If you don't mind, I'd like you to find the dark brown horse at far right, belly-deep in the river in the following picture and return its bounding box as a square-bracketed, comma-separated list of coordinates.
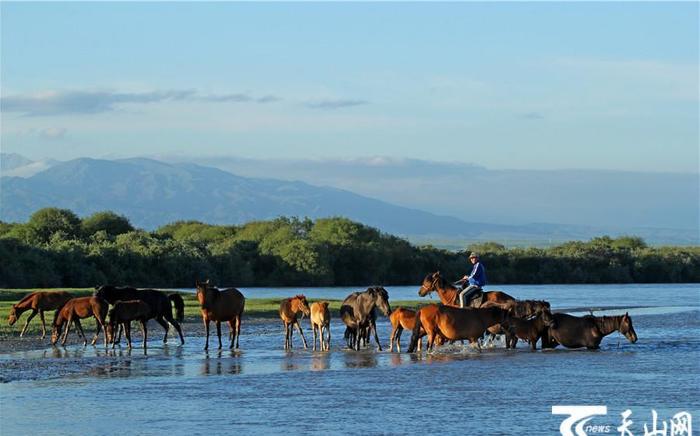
[545, 312, 637, 350]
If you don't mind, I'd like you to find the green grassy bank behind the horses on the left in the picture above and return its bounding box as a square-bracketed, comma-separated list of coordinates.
[0, 288, 428, 336]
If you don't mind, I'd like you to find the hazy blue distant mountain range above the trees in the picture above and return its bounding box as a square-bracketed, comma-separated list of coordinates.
[0, 154, 697, 245]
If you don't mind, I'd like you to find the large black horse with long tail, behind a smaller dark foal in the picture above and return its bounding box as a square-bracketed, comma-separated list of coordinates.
[94, 285, 185, 345]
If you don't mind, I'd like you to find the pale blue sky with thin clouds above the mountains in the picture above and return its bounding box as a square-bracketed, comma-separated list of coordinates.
[0, 2, 700, 173]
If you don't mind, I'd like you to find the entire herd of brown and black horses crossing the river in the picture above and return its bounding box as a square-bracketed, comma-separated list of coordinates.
[8, 272, 637, 352]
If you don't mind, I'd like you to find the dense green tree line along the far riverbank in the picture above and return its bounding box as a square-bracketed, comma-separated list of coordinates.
[0, 208, 700, 288]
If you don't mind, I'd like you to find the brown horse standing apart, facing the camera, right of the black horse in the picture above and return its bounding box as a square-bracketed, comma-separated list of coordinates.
[195, 280, 245, 350]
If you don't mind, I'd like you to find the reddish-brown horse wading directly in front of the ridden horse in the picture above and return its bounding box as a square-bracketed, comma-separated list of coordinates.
[408, 304, 509, 353]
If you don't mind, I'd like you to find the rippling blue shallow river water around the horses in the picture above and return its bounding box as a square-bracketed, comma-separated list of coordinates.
[0, 285, 700, 434]
